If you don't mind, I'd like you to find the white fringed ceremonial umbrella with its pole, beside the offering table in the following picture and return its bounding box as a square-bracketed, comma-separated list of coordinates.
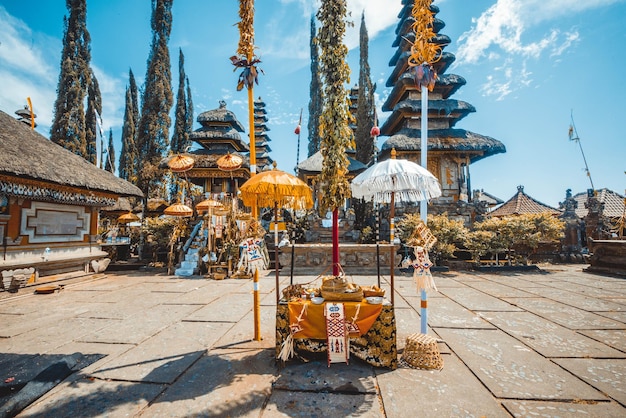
[350, 149, 441, 310]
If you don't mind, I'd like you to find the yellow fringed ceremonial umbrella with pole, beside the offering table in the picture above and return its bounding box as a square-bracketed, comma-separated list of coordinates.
[239, 165, 313, 303]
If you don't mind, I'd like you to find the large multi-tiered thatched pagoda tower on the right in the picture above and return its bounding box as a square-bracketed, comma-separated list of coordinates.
[380, 0, 506, 221]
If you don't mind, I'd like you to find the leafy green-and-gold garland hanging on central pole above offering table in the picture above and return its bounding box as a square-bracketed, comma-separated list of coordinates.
[317, 0, 353, 211]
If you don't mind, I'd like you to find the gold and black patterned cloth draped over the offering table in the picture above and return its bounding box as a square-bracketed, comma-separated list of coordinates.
[276, 300, 398, 370]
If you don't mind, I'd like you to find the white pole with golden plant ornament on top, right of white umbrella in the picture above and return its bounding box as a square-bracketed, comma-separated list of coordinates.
[408, 0, 441, 334]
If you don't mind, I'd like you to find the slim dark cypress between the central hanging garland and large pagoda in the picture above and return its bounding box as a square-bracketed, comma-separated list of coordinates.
[355, 13, 376, 164]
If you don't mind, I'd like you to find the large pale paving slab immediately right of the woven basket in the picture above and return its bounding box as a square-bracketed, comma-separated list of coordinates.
[436, 328, 607, 401]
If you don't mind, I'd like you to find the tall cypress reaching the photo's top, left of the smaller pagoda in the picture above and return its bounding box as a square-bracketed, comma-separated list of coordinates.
[136, 0, 173, 198]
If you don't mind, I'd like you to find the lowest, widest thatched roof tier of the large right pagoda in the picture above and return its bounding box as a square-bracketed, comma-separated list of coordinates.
[381, 128, 506, 162]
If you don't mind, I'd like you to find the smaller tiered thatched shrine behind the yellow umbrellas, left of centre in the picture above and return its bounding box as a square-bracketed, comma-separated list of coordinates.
[186, 101, 250, 194]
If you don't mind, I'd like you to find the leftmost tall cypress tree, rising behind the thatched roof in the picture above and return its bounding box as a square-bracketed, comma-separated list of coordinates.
[50, 0, 91, 158]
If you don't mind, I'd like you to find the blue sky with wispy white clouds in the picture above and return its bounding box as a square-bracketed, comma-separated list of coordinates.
[0, 0, 626, 207]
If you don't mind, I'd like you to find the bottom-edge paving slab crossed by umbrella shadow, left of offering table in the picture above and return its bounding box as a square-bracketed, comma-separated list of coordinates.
[143, 350, 276, 417]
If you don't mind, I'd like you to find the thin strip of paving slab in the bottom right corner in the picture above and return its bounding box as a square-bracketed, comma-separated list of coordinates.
[502, 401, 624, 418]
